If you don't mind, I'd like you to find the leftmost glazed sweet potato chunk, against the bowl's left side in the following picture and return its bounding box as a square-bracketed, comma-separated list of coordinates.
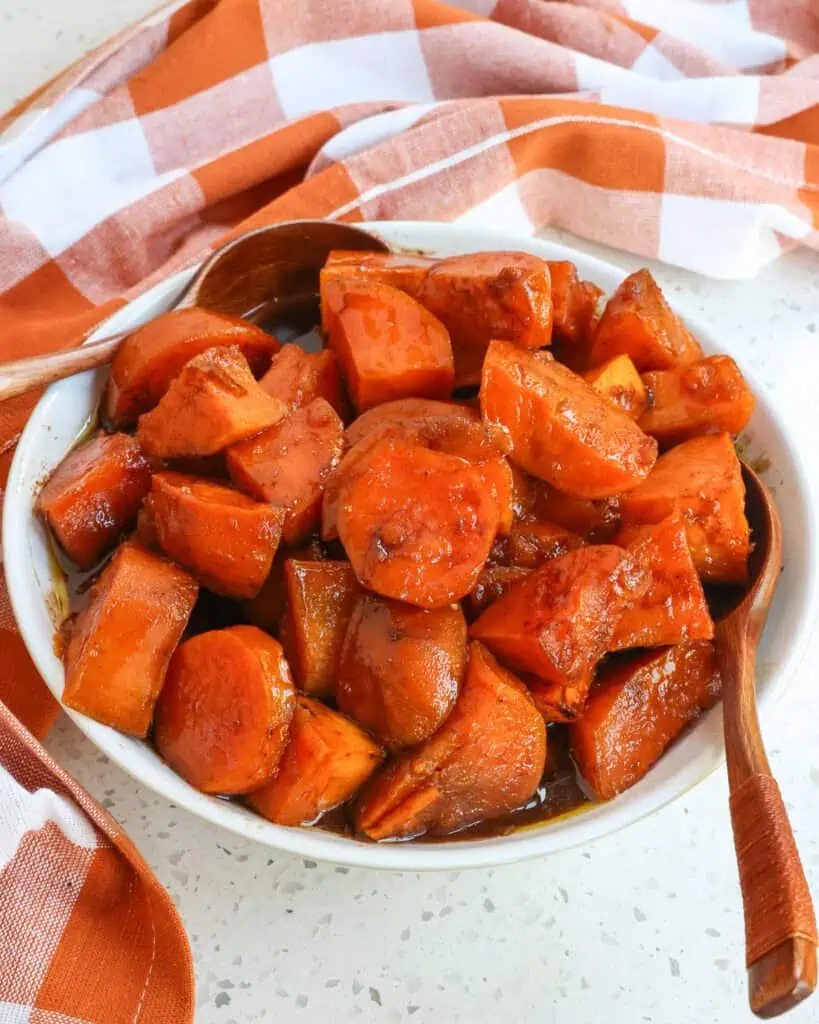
[36, 433, 150, 569]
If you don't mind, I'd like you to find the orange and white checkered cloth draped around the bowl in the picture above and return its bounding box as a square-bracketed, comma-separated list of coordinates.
[0, 0, 819, 1024]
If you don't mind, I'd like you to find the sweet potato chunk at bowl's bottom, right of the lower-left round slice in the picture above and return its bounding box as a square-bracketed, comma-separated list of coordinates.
[247, 693, 384, 825]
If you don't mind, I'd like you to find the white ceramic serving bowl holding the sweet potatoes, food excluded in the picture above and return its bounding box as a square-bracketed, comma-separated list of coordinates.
[3, 222, 819, 870]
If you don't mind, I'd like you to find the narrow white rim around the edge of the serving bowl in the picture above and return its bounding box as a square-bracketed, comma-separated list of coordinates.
[7, 221, 819, 871]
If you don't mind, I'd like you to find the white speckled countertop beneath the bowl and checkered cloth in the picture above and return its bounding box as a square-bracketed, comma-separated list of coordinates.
[0, 0, 819, 1024]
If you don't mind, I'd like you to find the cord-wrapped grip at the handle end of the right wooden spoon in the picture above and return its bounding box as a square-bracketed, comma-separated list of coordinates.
[731, 774, 817, 1017]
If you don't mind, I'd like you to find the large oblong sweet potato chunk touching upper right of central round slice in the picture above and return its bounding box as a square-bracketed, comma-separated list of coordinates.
[480, 341, 657, 498]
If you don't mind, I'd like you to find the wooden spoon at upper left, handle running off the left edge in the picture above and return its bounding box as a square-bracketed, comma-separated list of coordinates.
[0, 220, 387, 401]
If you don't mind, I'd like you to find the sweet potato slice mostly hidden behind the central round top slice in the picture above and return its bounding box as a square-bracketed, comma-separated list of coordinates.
[339, 398, 514, 537]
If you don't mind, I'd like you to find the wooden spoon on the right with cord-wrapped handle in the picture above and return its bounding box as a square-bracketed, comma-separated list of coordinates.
[715, 465, 817, 1018]
